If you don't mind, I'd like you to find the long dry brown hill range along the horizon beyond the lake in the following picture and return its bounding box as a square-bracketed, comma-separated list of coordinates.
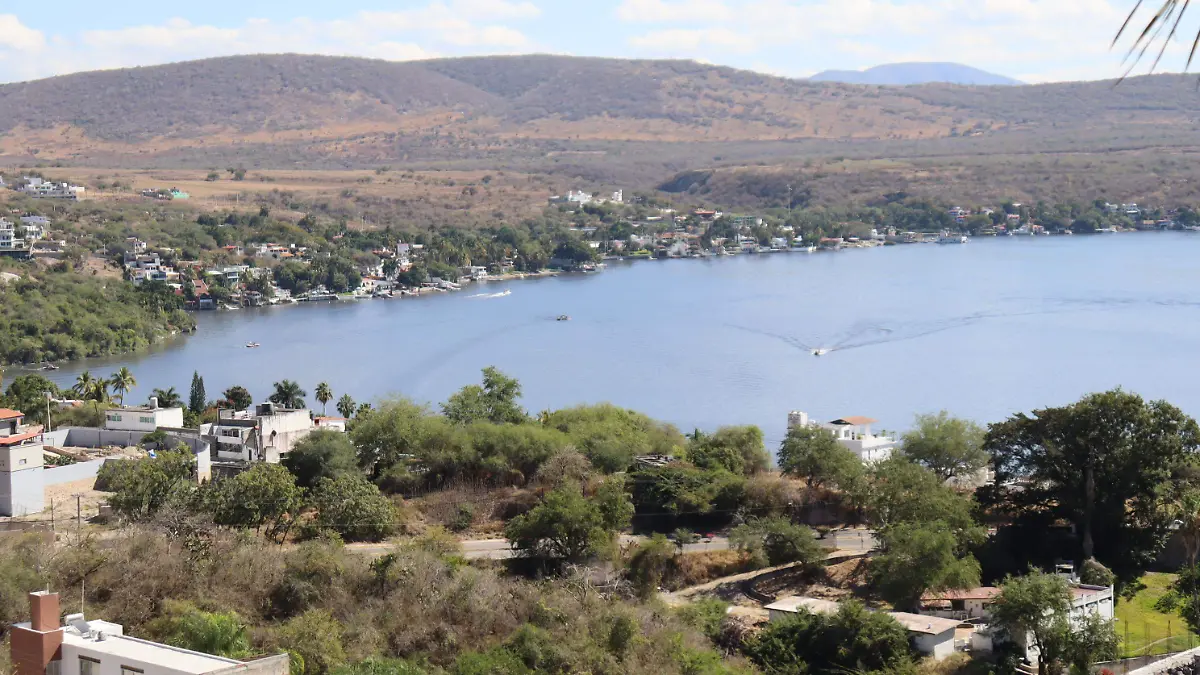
[7, 55, 1200, 198]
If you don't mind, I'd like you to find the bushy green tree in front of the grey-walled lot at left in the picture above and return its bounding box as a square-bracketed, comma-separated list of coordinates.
[96, 450, 196, 520]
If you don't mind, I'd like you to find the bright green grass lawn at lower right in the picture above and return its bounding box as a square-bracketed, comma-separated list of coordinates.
[1115, 573, 1200, 657]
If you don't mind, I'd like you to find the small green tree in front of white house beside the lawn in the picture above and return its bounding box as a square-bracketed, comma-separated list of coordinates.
[991, 571, 1070, 675]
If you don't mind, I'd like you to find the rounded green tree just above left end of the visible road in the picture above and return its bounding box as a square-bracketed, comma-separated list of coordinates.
[312, 473, 396, 542]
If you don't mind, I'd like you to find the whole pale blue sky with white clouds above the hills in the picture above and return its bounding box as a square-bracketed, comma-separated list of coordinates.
[0, 0, 1185, 83]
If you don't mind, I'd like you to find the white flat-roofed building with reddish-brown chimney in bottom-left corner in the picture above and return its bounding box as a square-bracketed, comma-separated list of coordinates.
[8, 591, 290, 675]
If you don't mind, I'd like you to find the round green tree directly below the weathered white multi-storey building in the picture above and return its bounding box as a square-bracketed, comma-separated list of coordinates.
[205, 464, 304, 542]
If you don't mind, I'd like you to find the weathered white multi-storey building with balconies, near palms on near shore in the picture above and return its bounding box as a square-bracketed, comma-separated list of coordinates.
[200, 404, 317, 465]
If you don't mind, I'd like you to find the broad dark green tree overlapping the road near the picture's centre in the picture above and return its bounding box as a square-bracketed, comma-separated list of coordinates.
[504, 485, 631, 562]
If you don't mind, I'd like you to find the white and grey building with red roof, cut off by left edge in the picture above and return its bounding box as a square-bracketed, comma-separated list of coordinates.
[0, 408, 46, 516]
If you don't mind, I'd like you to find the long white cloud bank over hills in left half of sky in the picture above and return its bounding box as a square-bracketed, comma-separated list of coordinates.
[0, 0, 540, 80]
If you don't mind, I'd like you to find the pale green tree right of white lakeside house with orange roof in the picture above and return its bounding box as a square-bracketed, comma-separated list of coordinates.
[902, 411, 989, 480]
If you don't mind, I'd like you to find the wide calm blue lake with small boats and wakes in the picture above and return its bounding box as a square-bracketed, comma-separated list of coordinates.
[30, 233, 1200, 443]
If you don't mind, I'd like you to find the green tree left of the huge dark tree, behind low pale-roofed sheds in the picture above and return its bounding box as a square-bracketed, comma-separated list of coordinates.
[869, 521, 979, 610]
